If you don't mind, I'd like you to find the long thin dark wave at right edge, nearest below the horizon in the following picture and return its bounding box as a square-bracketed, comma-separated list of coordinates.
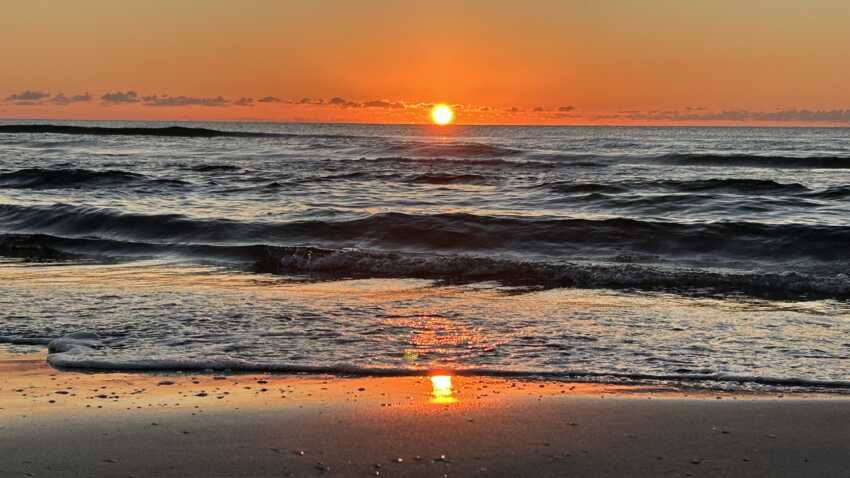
[638, 153, 850, 169]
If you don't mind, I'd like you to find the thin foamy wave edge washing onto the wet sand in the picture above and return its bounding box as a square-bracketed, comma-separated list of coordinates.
[0, 332, 850, 390]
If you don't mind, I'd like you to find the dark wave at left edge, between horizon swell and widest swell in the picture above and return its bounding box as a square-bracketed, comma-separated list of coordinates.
[0, 168, 189, 189]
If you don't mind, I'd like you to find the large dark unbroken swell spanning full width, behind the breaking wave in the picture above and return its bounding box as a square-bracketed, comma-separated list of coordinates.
[0, 204, 850, 262]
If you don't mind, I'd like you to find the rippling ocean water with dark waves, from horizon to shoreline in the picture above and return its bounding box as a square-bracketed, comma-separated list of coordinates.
[0, 121, 850, 391]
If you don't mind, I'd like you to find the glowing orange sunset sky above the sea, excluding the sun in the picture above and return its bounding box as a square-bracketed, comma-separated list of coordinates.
[0, 0, 850, 124]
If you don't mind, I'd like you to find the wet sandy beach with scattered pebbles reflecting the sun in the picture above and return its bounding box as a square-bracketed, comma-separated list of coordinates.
[0, 353, 850, 478]
